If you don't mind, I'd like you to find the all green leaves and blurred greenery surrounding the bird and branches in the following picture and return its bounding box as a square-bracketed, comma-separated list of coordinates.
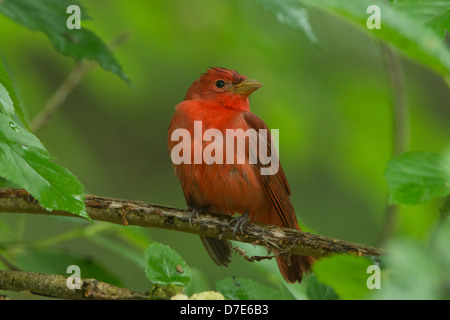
[0, 0, 450, 299]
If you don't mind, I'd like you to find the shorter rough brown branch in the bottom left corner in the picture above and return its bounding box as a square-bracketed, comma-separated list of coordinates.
[0, 270, 149, 300]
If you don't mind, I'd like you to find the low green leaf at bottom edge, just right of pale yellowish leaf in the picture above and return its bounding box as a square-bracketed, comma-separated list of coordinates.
[216, 277, 284, 300]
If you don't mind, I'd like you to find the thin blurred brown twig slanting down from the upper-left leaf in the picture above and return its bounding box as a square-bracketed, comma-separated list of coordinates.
[30, 32, 129, 132]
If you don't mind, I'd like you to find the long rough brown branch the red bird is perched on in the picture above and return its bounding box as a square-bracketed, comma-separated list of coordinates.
[0, 189, 383, 257]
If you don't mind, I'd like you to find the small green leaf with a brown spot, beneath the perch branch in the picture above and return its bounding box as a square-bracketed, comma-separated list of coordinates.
[145, 242, 191, 287]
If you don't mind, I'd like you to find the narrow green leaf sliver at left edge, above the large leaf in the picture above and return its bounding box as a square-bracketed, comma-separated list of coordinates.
[0, 59, 29, 129]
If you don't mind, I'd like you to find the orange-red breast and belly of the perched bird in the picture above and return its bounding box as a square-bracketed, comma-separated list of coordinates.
[169, 100, 264, 214]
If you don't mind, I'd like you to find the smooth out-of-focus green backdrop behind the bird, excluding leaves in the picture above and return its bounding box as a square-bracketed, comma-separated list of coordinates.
[0, 0, 450, 291]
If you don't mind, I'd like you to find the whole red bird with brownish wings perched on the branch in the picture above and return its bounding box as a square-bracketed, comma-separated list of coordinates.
[168, 68, 314, 282]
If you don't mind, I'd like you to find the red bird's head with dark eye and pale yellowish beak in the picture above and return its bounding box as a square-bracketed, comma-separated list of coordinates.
[185, 67, 262, 111]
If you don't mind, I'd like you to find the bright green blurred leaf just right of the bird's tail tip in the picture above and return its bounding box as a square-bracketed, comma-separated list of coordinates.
[313, 254, 373, 300]
